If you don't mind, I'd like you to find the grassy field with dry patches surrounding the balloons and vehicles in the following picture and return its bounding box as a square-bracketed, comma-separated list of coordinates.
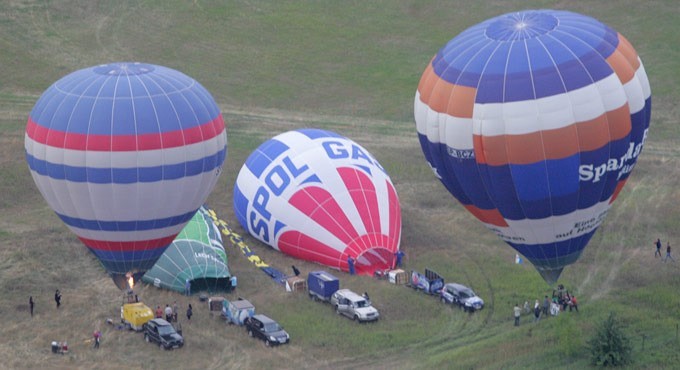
[0, 0, 680, 369]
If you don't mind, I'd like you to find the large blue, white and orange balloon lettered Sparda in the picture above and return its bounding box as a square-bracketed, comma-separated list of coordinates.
[414, 10, 651, 284]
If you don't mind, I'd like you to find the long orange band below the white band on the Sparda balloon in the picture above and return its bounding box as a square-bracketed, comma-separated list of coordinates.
[473, 104, 631, 166]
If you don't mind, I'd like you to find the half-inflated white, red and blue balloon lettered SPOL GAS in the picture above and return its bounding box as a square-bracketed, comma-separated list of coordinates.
[234, 129, 401, 274]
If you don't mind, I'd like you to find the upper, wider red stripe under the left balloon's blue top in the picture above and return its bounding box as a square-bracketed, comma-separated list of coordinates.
[26, 114, 224, 152]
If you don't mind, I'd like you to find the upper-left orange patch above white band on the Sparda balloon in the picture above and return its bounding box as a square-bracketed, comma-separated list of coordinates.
[418, 63, 477, 118]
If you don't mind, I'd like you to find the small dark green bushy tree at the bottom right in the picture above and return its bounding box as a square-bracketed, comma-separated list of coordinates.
[588, 312, 633, 366]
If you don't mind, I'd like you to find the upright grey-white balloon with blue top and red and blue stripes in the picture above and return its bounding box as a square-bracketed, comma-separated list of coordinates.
[25, 62, 227, 289]
